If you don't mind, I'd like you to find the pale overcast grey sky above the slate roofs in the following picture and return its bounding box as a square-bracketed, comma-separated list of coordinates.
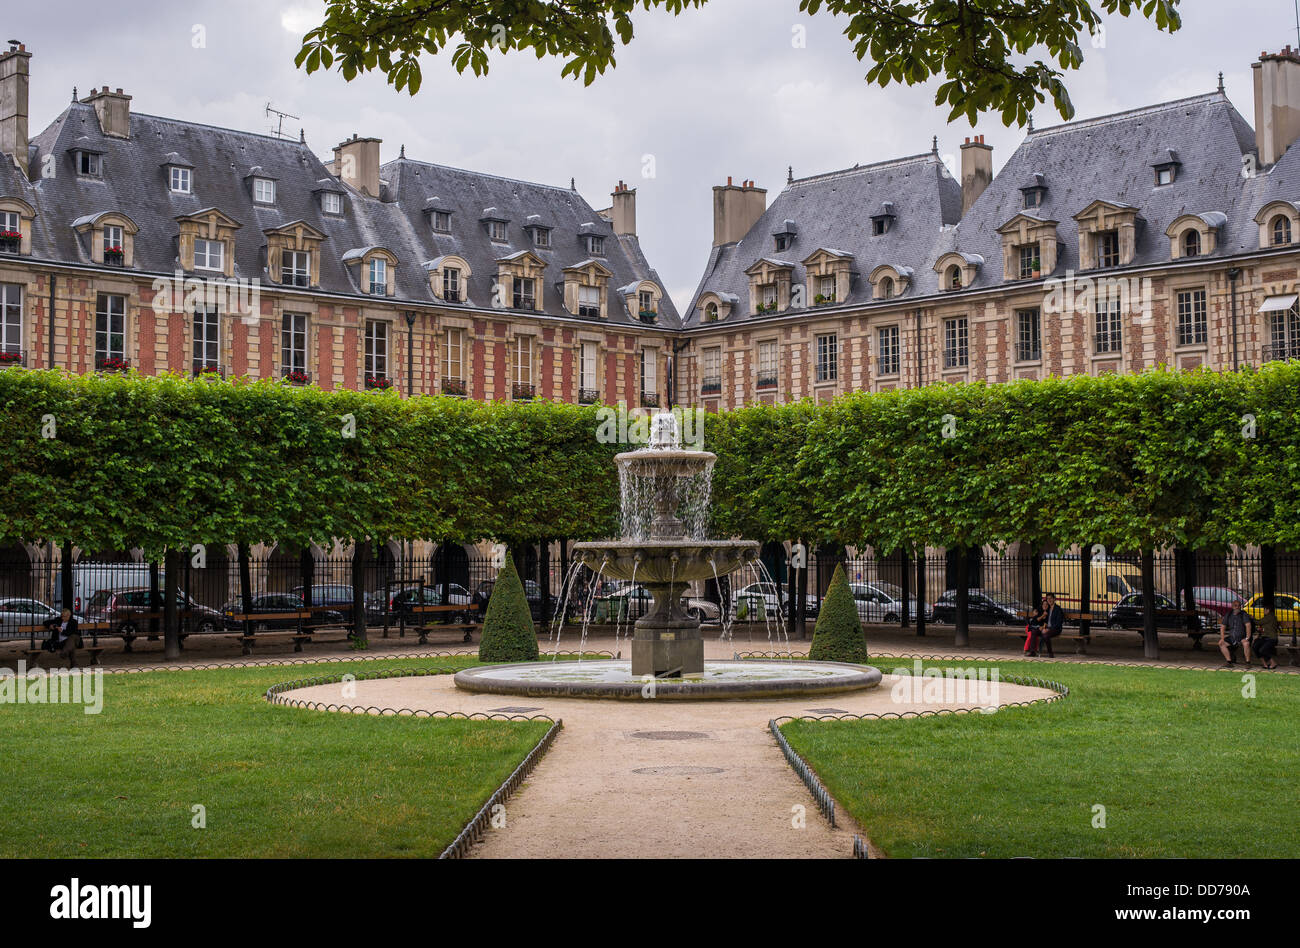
[10, 0, 1300, 308]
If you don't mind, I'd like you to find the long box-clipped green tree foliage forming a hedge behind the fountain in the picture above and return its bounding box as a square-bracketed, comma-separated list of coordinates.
[0, 363, 1300, 553]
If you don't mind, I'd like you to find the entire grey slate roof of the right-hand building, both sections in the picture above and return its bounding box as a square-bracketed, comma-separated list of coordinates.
[686, 91, 1300, 326]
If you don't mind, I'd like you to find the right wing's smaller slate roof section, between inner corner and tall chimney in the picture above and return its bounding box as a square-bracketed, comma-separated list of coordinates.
[684, 152, 962, 326]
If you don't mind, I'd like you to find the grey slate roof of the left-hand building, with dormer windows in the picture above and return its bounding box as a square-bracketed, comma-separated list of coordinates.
[10, 101, 679, 329]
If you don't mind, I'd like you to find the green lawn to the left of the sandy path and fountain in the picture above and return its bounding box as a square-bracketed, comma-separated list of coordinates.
[0, 658, 549, 858]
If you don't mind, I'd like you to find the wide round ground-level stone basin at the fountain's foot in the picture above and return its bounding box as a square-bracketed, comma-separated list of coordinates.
[455, 659, 880, 701]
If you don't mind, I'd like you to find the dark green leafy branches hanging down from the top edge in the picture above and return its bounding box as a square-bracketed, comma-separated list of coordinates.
[294, 0, 1182, 125]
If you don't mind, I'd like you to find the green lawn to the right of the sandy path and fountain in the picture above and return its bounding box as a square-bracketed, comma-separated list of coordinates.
[783, 659, 1300, 858]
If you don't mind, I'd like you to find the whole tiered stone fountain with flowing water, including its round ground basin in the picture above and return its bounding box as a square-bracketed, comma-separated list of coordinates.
[455, 412, 880, 698]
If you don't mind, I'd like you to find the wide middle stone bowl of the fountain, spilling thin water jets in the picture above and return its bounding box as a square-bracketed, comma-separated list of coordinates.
[573, 540, 759, 583]
